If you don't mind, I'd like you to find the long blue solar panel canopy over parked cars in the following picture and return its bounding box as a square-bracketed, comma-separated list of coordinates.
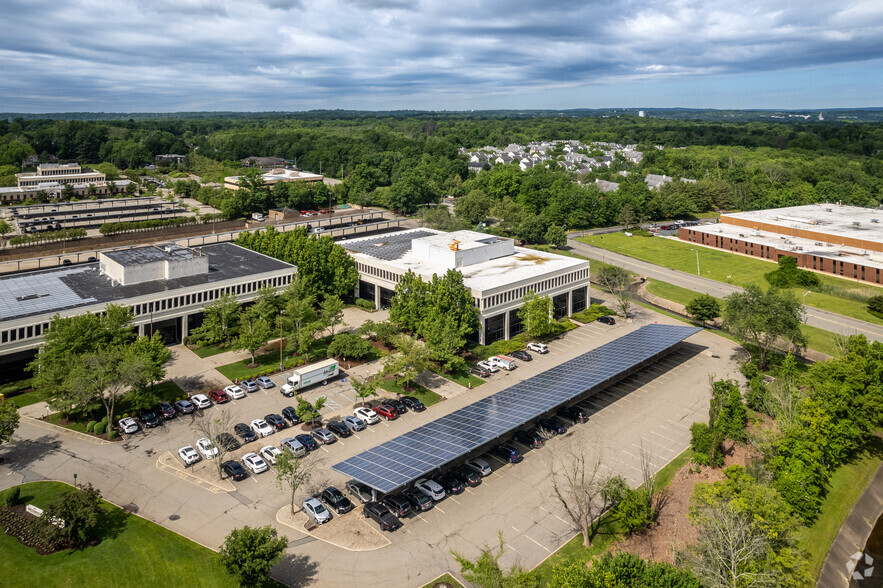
[331, 324, 701, 492]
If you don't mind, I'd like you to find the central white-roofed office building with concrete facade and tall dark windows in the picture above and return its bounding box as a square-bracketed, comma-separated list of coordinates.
[340, 229, 589, 345]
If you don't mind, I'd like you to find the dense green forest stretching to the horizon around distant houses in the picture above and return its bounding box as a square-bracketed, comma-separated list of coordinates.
[0, 112, 883, 234]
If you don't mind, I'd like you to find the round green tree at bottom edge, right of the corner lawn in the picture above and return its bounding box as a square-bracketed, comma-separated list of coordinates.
[220, 525, 288, 586]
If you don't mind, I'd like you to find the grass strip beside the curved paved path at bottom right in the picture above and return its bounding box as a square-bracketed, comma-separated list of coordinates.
[798, 437, 883, 584]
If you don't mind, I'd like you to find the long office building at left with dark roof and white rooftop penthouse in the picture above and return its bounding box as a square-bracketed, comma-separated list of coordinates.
[0, 243, 296, 382]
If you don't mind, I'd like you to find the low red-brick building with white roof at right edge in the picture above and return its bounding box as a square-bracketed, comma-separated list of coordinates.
[679, 204, 883, 284]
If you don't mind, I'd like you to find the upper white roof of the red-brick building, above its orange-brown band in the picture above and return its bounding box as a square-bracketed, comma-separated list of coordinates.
[721, 204, 883, 243]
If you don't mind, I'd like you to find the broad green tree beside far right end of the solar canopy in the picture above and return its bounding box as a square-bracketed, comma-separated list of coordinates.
[724, 284, 806, 370]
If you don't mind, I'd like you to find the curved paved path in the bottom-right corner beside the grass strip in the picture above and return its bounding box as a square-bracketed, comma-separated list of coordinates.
[816, 465, 883, 588]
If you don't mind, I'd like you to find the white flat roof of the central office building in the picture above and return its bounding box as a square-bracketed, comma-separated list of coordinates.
[339, 229, 589, 291]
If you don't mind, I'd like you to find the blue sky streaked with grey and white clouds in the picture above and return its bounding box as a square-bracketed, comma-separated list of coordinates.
[0, 0, 883, 112]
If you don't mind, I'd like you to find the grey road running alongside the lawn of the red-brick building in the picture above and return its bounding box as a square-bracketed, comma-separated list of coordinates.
[567, 238, 883, 341]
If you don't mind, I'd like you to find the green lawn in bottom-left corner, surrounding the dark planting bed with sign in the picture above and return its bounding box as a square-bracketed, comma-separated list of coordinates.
[0, 482, 238, 588]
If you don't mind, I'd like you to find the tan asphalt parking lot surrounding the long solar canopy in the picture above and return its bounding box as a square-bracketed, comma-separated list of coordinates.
[0, 310, 740, 586]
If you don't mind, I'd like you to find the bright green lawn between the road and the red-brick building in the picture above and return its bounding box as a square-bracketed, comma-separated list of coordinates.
[579, 233, 883, 324]
